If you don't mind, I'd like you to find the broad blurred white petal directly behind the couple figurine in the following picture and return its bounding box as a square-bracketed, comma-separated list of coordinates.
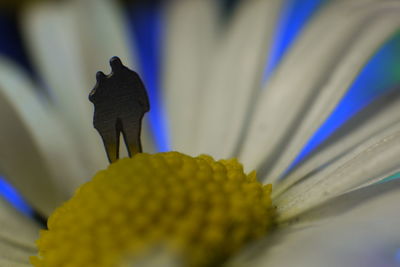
[22, 0, 153, 161]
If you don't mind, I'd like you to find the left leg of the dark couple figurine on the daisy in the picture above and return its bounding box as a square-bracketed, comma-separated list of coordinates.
[95, 123, 119, 163]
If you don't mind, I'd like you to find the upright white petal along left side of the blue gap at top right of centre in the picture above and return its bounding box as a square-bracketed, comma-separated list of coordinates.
[196, 0, 281, 158]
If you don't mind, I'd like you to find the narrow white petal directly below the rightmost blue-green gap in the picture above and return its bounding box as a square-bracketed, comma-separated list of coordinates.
[272, 91, 400, 197]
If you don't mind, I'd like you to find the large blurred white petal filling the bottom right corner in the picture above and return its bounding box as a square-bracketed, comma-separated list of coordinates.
[230, 181, 400, 267]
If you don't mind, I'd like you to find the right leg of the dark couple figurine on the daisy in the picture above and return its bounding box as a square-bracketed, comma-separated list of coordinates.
[122, 118, 142, 157]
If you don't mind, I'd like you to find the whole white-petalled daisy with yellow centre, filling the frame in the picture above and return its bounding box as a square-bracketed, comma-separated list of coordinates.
[0, 0, 400, 266]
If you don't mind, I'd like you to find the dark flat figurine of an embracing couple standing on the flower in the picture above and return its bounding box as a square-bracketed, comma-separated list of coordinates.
[89, 57, 150, 163]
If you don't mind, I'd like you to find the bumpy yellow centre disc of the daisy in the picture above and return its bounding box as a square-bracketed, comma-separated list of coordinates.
[31, 152, 274, 267]
